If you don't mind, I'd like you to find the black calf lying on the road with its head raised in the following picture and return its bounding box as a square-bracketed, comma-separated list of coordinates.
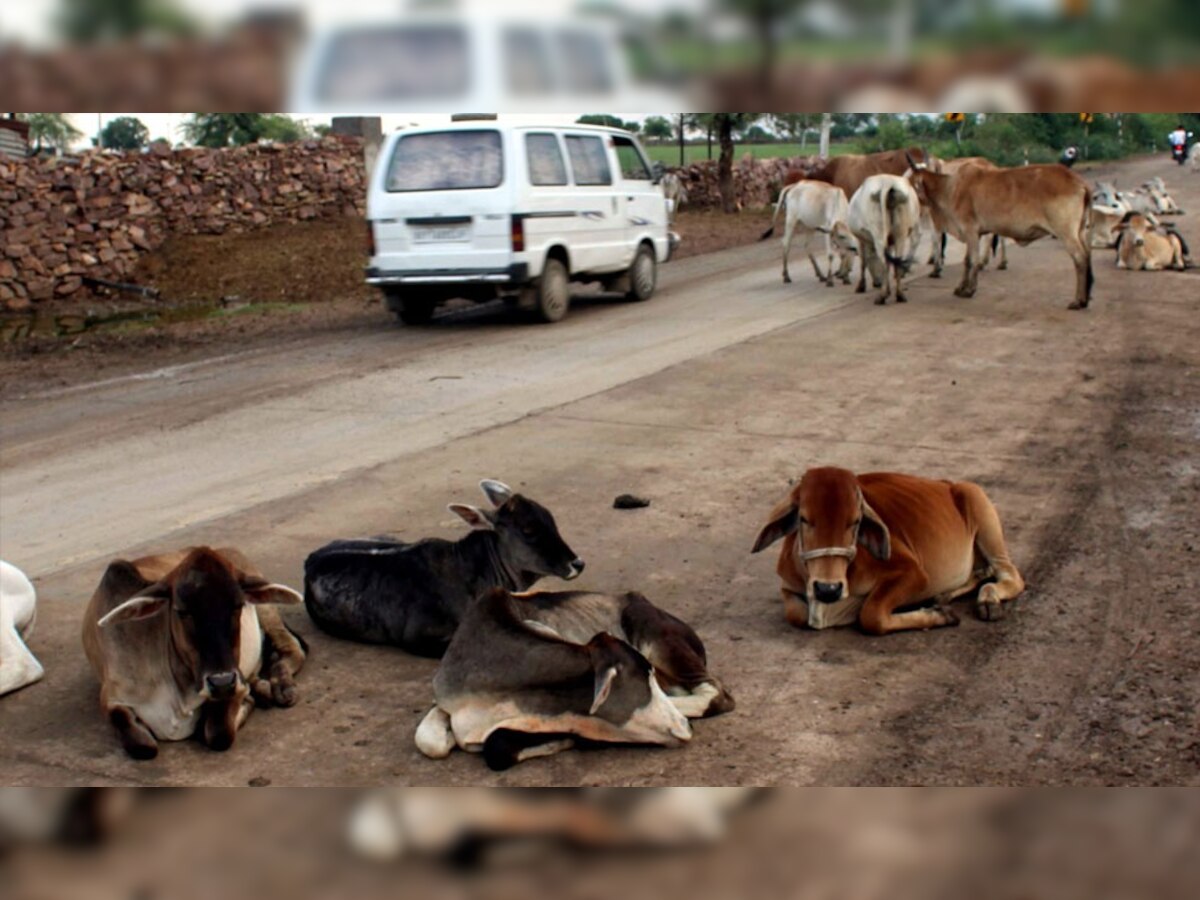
[304, 479, 583, 656]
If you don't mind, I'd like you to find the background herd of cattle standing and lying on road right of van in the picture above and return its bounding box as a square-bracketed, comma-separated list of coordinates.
[748, 148, 1190, 310]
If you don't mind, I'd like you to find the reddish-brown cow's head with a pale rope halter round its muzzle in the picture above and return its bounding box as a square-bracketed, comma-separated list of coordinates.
[751, 468, 892, 604]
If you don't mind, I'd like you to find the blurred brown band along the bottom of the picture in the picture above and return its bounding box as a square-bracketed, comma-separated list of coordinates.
[0, 787, 1200, 900]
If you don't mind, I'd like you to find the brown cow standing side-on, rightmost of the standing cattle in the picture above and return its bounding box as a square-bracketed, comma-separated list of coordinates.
[910, 160, 1093, 310]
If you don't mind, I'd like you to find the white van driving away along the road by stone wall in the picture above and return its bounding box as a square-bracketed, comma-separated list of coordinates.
[367, 118, 678, 324]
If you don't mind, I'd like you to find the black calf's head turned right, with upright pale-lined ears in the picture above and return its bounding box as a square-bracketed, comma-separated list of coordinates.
[450, 480, 584, 581]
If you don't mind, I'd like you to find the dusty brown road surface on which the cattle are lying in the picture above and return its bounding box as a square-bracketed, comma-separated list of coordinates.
[0, 160, 1200, 785]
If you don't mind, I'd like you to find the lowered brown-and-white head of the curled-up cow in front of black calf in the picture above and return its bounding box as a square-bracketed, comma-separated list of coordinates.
[587, 632, 691, 746]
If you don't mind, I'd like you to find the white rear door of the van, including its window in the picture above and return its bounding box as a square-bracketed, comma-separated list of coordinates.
[371, 128, 511, 274]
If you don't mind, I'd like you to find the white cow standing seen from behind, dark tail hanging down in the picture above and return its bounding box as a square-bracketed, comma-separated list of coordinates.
[848, 175, 921, 305]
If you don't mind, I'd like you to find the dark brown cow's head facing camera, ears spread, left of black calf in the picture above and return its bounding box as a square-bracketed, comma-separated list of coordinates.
[98, 547, 302, 701]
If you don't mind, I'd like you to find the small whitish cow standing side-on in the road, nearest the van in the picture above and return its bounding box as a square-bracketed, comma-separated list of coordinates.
[758, 181, 858, 287]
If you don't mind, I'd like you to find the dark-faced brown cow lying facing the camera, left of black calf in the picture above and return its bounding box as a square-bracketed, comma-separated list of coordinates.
[83, 547, 306, 760]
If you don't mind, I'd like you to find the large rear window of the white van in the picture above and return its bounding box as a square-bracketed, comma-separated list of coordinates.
[386, 130, 504, 192]
